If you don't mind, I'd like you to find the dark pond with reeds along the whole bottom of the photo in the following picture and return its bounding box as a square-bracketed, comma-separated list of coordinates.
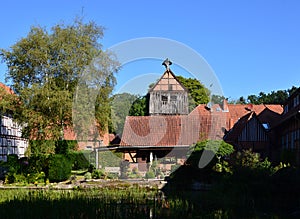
[0, 186, 299, 219]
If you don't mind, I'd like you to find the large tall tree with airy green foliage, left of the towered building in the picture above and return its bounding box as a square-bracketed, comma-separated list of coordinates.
[0, 19, 118, 139]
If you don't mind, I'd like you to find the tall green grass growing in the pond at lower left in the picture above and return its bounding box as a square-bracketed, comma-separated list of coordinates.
[0, 187, 202, 219]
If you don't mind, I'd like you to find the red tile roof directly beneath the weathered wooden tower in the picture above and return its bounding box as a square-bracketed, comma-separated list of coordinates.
[121, 115, 199, 147]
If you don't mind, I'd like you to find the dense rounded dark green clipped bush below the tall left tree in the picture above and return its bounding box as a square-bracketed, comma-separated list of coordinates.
[48, 154, 72, 182]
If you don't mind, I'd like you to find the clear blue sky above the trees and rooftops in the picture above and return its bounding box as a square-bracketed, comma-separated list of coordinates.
[0, 0, 300, 99]
